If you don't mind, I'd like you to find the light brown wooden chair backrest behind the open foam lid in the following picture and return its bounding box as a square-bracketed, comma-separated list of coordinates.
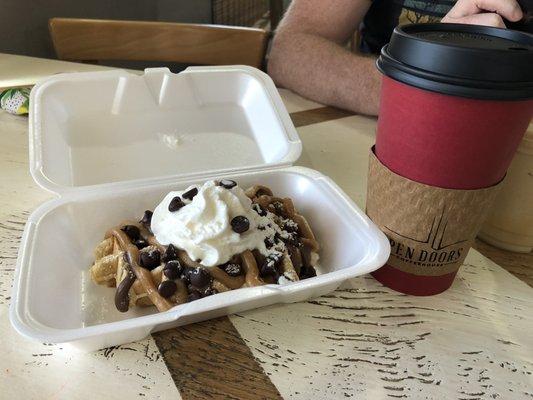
[49, 18, 268, 68]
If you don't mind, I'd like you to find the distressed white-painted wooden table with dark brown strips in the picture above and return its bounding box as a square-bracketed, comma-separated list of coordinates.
[0, 55, 533, 400]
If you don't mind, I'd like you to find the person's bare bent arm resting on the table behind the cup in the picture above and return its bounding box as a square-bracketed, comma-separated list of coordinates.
[268, 0, 381, 115]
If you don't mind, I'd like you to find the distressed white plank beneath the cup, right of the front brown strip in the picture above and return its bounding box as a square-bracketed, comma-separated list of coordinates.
[231, 250, 533, 400]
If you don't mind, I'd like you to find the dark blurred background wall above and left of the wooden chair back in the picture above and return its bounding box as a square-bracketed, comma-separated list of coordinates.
[0, 0, 289, 58]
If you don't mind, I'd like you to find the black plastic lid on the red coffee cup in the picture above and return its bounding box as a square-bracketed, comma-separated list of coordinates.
[377, 24, 533, 100]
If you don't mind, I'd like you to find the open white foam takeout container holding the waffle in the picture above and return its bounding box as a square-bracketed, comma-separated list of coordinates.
[10, 66, 389, 351]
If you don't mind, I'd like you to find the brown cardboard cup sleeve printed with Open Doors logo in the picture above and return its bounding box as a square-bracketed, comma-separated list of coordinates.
[366, 149, 501, 276]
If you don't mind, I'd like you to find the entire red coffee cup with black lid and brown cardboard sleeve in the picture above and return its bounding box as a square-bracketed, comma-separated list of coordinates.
[367, 24, 533, 295]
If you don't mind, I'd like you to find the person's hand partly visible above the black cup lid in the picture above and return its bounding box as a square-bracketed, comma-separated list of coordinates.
[441, 0, 523, 28]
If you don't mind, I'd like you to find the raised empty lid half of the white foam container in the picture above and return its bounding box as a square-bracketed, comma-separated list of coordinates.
[29, 66, 302, 194]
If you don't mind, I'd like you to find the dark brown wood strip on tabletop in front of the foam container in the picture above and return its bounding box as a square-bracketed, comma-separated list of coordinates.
[153, 317, 282, 400]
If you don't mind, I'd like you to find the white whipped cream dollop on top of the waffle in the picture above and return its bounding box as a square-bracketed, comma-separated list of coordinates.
[151, 181, 283, 267]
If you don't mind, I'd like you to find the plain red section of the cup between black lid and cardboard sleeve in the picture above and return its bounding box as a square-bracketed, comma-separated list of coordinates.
[376, 78, 533, 189]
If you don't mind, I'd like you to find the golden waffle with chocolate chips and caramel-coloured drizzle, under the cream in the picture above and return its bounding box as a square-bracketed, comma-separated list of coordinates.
[90, 185, 319, 312]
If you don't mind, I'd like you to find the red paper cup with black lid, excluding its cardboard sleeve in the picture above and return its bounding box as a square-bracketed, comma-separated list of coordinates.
[373, 24, 533, 295]
